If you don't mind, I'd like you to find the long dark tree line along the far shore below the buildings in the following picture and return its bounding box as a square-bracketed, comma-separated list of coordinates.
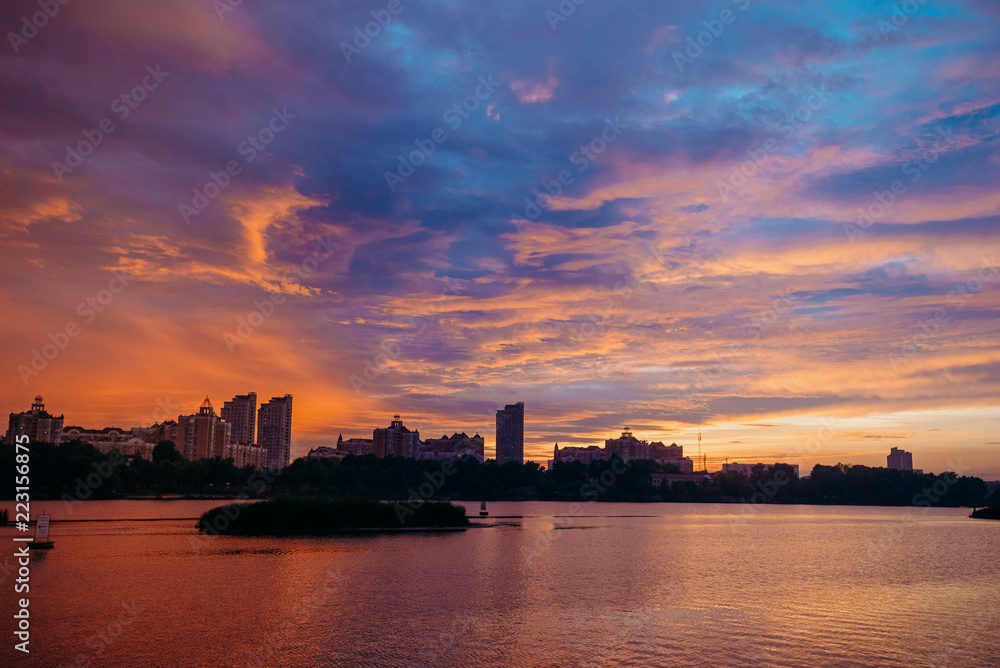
[0, 441, 1000, 507]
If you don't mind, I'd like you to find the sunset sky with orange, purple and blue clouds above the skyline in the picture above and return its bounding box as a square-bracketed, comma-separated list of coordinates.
[0, 0, 1000, 480]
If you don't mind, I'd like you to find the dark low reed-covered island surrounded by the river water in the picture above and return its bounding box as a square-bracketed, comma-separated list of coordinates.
[198, 497, 470, 536]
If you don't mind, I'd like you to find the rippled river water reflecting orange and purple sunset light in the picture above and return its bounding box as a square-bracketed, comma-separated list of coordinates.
[0, 501, 1000, 668]
